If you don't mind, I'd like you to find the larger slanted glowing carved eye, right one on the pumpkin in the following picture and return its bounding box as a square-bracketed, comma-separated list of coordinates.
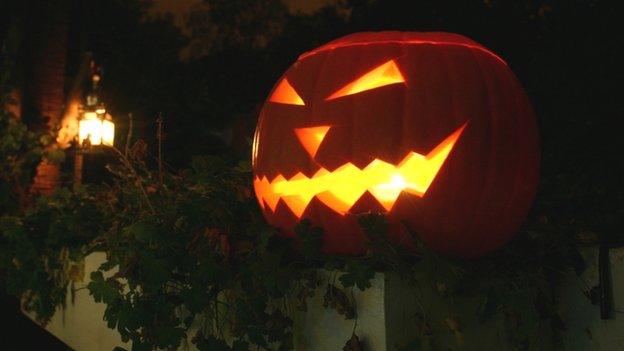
[326, 60, 405, 100]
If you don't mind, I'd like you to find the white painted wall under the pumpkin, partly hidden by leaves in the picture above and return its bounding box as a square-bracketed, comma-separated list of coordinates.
[24, 249, 624, 351]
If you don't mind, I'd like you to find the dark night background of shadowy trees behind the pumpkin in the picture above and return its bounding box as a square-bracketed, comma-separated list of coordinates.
[0, 0, 624, 350]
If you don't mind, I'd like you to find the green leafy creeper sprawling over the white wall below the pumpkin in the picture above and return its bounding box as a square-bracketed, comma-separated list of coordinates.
[0, 135, 582, 350]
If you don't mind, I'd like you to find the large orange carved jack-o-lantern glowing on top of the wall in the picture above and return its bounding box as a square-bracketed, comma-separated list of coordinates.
[253, 32, 539, 257]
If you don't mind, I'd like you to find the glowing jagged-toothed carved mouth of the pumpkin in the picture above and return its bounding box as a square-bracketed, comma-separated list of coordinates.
[254, 123, 466, 218]
